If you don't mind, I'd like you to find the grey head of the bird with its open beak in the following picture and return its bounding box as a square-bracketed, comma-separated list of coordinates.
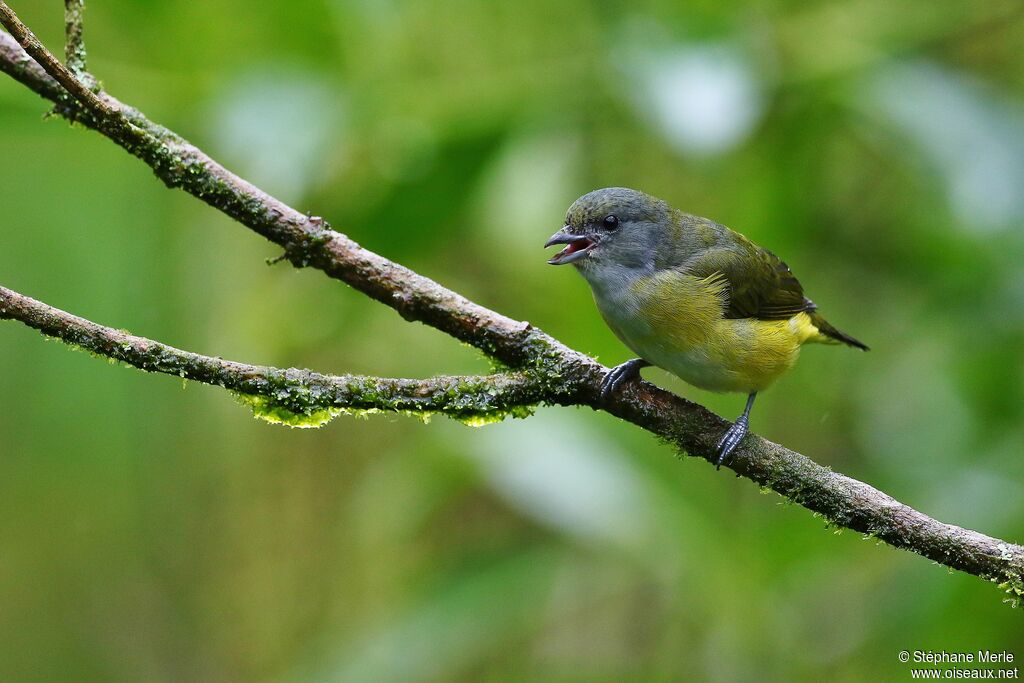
[544, 187, 671, 275]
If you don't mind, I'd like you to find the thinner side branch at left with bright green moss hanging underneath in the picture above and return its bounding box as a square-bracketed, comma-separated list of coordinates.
[0, 287, 555, 427]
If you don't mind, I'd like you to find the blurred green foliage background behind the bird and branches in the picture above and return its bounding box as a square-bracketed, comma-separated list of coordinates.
[0, 0, 1024, 682]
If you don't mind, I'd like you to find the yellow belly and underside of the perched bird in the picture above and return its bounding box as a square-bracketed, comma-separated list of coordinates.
[598, 272, 819, 393]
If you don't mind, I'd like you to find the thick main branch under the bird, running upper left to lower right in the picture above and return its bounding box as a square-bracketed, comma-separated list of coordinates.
[0, 2, 1024, 601]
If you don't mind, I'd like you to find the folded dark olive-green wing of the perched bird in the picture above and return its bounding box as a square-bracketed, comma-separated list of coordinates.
[684, 242, 814, 321]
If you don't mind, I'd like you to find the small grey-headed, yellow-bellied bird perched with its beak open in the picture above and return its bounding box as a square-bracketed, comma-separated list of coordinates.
[544, 187, 867, 467]
